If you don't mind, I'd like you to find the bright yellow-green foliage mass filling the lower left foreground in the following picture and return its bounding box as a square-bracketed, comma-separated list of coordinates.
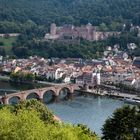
[0, 100, 98, 140]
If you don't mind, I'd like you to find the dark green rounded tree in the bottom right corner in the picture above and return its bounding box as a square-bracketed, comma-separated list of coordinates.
[102, 106, 140, 140]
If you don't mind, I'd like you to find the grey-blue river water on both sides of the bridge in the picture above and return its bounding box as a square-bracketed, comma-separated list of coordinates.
[0, 82, 129, 135]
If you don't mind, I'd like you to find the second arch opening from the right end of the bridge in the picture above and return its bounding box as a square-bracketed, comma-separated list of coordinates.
[43, 89, 56, 104]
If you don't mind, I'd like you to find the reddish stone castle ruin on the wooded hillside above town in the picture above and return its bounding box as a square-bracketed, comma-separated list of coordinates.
[44, 23, 120, 41]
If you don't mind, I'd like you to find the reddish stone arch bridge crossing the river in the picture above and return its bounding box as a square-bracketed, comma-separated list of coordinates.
[0, 84, 79, 104]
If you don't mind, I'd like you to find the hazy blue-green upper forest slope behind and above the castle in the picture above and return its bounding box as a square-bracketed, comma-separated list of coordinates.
[0, 0, 140, 31]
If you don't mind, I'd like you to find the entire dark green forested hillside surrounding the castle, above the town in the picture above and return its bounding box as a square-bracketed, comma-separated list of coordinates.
[0, 0, 140, 58]
